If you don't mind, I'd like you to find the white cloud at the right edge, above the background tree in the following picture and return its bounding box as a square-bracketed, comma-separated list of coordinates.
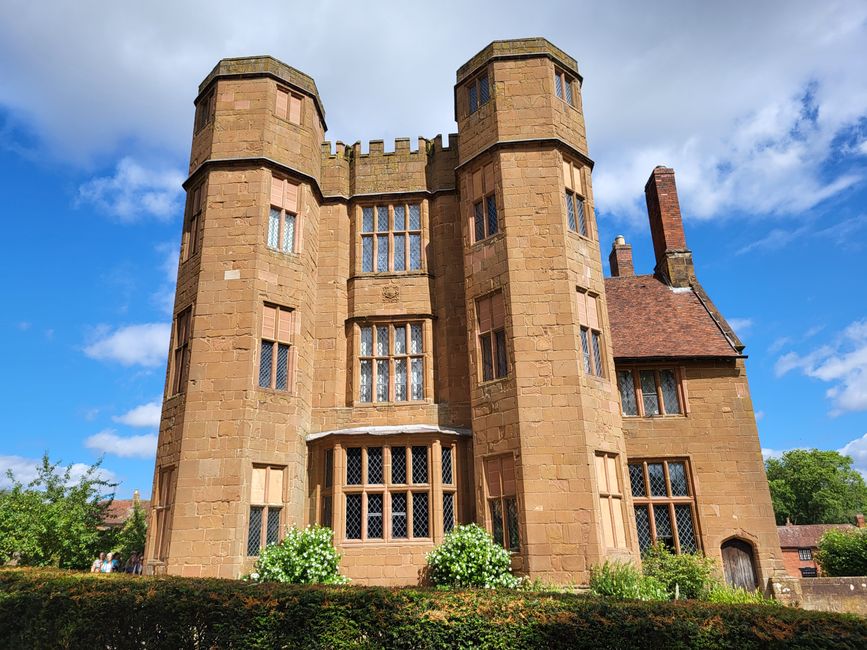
[774, 320, 867, 415]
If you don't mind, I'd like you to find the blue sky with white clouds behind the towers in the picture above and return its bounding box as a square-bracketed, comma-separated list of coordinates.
[0, 0, 867, 497]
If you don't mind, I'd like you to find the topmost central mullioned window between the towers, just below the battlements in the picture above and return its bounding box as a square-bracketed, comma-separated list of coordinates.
[359, 203, 424, 273]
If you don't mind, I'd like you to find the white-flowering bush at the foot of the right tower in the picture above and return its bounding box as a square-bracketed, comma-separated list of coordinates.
[427, 524, 520, 589]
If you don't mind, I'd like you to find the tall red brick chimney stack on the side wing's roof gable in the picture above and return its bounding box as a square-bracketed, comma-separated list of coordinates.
[644, 166, 695, 287]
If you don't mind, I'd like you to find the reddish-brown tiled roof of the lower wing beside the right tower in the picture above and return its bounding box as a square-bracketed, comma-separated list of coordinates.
[605, 275, 740, 359]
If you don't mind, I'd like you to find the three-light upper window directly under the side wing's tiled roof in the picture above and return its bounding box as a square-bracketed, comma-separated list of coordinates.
[617, 367, 686, 417]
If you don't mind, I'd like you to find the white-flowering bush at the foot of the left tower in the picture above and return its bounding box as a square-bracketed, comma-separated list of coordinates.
[250, 526, 349, 585]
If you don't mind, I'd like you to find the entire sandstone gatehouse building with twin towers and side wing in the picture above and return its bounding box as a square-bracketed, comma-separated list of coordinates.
[147, 39, 782, 584]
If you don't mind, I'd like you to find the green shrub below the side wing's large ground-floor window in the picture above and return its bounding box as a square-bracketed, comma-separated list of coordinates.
[641, 544, 719, 599]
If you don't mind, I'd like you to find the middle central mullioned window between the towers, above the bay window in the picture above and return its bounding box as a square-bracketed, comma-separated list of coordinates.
[358, 321, 426, 402]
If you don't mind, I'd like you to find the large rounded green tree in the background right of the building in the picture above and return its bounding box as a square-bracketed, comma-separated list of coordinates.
[765, 449, 867, 525]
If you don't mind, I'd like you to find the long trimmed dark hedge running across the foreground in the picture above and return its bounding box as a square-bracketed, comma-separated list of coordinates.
[0, 569, 867, 650]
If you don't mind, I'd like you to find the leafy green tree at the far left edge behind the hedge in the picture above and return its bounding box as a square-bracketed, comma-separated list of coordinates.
[0, 454, 116, 569]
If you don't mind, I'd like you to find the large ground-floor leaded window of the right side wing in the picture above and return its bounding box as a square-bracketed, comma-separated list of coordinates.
[629, 459, 700, 553]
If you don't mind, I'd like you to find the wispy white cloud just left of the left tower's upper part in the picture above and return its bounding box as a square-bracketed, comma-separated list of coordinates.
[78, 157, 184, 223]
